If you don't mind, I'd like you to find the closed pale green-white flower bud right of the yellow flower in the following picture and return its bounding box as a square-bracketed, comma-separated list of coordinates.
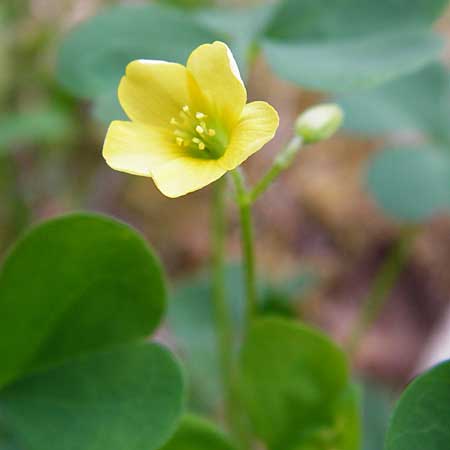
[295, 103, 344, 144]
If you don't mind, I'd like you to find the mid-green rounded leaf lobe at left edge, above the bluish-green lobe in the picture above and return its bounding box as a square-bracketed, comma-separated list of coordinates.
[0, 214, 166, 385]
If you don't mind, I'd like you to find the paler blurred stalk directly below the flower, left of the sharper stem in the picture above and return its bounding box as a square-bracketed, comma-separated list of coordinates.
[212, 177, 233, 423]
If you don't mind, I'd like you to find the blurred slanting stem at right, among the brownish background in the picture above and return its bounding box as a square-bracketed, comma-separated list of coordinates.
[346, 227, 418, 356]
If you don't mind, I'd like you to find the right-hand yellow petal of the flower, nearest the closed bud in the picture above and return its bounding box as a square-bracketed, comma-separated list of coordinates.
[218, 102, 279, 170]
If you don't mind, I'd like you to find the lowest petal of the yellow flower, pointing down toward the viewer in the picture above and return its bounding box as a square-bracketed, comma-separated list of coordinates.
[153, 156, 226, 198]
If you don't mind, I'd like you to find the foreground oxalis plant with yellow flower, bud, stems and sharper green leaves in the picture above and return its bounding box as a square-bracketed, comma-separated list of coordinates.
[0, 37, 450, 450]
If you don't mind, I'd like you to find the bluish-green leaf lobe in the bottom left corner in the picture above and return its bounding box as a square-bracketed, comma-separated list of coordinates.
[0, 343, 183, 450]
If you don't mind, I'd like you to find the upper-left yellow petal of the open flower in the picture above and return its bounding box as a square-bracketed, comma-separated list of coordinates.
[119, 59, 190, 127]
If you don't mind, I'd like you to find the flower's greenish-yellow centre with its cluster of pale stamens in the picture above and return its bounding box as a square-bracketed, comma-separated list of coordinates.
[170, 105, 228, 159]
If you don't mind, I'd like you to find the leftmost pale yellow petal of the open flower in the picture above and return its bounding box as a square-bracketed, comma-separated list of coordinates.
[103, 121, 182, 177]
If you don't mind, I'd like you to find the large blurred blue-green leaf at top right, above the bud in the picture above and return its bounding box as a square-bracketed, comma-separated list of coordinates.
[263, 0, 448, 92]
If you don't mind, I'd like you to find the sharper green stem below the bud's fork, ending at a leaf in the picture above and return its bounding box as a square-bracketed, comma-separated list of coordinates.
[231, 169, 257, 330]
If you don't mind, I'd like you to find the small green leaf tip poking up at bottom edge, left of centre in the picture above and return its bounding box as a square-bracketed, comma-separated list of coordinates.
[160, 416, 234, 450]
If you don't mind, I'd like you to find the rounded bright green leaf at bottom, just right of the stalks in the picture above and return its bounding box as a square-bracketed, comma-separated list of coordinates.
[239, 318, 360, 450]
